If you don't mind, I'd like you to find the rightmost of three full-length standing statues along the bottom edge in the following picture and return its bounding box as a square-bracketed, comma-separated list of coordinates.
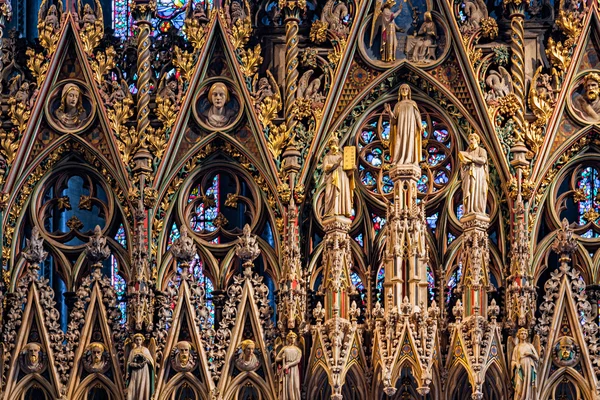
[510, 328, 539, 400]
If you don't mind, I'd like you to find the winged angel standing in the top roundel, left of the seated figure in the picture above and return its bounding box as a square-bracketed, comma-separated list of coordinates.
[369, 0, 402, 62]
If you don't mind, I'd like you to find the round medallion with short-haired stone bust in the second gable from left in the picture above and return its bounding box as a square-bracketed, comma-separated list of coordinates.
[193, 78, 243, 131]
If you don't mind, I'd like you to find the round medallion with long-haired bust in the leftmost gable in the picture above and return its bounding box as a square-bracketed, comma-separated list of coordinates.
[45, 79, 96, 133]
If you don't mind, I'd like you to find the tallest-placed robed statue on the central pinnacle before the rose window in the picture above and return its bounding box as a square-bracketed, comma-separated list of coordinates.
[385, 83, 423, 166]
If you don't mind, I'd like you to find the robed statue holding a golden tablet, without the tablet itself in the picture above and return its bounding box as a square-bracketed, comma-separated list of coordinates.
[323, 138, 354, 217]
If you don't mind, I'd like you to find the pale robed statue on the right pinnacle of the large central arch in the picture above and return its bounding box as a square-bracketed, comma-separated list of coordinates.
[458, 133, 488, 214]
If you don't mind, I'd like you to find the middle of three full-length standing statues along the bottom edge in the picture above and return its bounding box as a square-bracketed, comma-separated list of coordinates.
[275, 331, 302, 400]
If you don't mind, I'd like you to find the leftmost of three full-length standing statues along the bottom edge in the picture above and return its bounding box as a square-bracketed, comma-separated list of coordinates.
[126, 333, 154, 400]
